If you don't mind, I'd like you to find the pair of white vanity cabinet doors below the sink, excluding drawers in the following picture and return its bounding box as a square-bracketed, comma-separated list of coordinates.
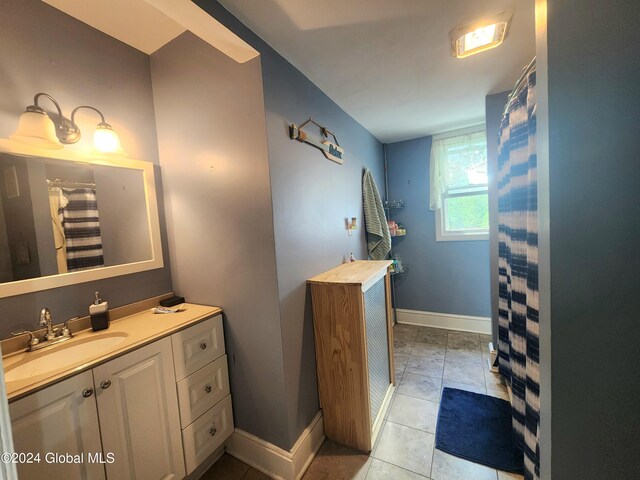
[9, 338, 185, 480]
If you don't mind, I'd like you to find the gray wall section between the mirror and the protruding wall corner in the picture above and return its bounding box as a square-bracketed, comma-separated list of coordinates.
[151, 32, 288, 445]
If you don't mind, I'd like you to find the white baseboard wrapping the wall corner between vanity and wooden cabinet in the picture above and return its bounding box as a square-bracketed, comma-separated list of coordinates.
[227, 411, 325, 480]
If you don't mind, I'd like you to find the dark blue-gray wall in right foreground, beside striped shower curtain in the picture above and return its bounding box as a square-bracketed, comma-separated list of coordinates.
[538, 0, 640, 480]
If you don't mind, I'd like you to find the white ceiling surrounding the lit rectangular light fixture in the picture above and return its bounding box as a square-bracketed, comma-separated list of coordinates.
[219, 0, 535, 142]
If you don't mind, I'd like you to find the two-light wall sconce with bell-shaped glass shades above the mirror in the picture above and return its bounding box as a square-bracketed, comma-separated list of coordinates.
[9, 92, 127, 156]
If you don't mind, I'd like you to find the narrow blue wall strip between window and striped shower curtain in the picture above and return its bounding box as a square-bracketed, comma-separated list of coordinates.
[485, 92, 509, 348]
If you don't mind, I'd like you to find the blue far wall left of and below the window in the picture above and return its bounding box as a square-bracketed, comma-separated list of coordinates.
[387, 137, 491, 317]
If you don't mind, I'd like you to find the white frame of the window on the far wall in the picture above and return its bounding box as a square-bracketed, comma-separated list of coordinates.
[432, 124, 489, 242]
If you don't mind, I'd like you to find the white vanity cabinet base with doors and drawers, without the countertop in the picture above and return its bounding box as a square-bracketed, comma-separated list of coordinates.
[9, 315, 233, 480]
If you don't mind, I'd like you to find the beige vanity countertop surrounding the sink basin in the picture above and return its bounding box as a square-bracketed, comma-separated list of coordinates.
[2, 303, 222, 401]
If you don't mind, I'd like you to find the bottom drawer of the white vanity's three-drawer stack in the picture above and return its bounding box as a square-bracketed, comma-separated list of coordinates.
[182, 395, 233, 475]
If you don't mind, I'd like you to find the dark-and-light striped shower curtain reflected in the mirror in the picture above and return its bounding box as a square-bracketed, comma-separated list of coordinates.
[62, 188, 104, 272]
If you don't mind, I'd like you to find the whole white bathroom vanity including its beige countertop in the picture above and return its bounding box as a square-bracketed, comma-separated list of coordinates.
[3, 304, 233, 480]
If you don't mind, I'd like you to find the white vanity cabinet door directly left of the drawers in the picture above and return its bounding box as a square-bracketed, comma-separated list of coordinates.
[93, 338, 185, 480]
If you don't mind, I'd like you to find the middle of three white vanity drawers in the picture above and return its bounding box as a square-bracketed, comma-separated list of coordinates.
[178, 355, 229, 428]
